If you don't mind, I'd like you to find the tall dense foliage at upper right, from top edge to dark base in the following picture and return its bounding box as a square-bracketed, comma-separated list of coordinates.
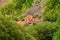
[43, 0, 60, 22]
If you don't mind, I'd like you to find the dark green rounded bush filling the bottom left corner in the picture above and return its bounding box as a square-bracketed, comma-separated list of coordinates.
[0, 17, 25, 40]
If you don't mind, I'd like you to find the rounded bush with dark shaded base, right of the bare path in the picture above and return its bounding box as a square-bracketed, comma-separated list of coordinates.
[43, 10, 57, 22]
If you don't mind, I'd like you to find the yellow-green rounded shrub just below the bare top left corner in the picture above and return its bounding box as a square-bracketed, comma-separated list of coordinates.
[0, 4, 15, 15]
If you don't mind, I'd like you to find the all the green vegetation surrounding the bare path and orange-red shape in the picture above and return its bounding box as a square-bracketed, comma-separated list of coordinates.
[0, 0, 60, 40]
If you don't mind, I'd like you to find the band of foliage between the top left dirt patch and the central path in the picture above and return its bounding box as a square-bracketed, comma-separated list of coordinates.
[0, 0, 33, 15]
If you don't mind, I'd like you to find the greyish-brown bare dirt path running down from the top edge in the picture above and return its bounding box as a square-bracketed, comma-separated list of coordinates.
[25, 0, 45, 15]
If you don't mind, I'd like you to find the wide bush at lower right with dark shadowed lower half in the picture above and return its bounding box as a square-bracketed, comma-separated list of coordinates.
[25, 22, 59, 40]
